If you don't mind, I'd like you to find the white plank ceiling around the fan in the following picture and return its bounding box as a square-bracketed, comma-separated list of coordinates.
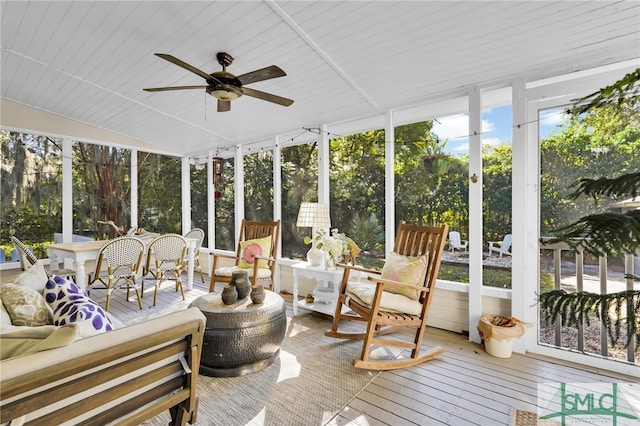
[0, 0, 640, 156]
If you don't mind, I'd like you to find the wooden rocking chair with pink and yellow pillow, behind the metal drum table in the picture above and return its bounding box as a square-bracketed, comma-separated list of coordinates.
[209, 219, 280, 292]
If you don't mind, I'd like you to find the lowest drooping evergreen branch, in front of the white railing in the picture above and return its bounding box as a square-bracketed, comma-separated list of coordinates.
[540, 290, 640, 350]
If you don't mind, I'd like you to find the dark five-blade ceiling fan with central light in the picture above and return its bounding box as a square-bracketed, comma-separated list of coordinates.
[142, 52, 293, 112]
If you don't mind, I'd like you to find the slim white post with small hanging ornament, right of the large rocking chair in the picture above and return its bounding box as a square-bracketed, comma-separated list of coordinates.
[469, 88, 483, 343]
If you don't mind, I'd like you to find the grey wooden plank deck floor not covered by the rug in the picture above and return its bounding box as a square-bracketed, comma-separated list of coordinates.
[77, 278, 638, 426]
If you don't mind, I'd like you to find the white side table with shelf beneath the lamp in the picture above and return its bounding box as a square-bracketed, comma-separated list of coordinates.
[291, 262, 344, 316]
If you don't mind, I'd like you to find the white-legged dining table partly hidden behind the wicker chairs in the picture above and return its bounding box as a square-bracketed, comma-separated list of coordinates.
[47, 238, 198, 290]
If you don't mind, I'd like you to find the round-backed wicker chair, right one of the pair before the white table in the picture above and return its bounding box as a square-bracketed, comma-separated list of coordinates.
[142, 234, 187, 306]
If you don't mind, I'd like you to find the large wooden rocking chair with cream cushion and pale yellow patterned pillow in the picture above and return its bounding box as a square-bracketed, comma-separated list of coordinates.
[325, 221, 449, 370]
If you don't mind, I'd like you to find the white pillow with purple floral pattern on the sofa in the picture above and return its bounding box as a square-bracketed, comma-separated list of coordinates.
[43, 276, 114, 334]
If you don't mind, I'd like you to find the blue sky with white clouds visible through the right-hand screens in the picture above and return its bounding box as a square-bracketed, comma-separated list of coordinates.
[433, 105, 563, 155]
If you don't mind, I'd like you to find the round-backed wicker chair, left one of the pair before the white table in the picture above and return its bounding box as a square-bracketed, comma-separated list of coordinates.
[87, 237, 144, 312]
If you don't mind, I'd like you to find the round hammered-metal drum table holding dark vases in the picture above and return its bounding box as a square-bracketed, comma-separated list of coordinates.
[191, 290, 287, 377]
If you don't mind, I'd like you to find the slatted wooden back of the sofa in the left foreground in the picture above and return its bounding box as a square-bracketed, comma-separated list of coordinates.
[0, 308, 205, 425]
